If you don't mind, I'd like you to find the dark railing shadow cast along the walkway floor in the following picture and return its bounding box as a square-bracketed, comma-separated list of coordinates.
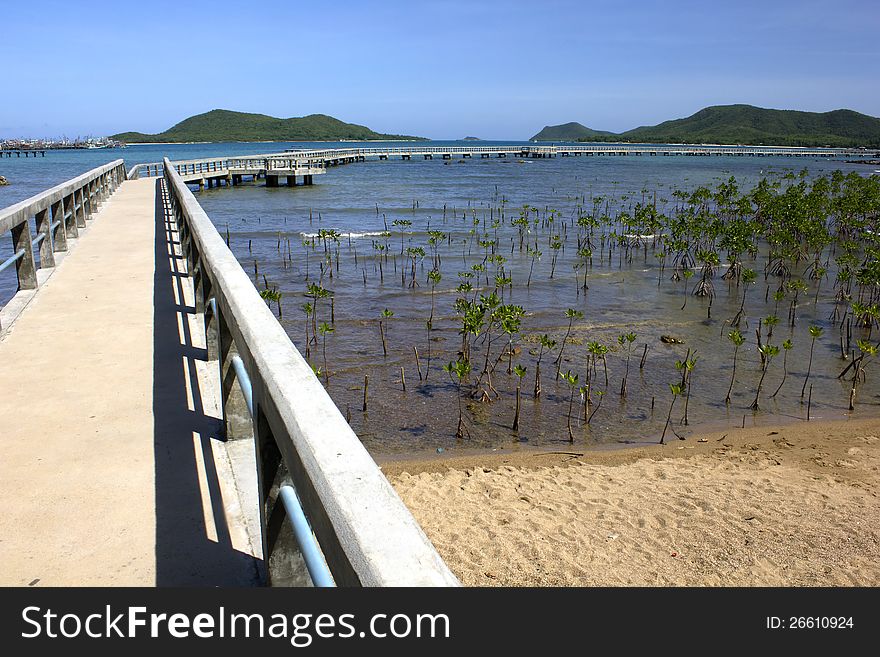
[153, 179, 258, 586]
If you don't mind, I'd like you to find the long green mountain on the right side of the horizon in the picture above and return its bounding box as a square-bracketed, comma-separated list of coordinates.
[532, 105, 880, 147]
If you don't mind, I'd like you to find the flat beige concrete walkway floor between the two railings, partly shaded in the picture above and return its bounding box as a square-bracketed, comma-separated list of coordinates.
[0, 179, 259, 586]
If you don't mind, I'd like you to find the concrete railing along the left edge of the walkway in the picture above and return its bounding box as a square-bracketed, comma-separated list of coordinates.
[0, 160, 126, 330]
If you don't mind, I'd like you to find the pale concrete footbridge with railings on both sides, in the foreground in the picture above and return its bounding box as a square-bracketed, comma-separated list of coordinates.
[0, 158, 458, 586]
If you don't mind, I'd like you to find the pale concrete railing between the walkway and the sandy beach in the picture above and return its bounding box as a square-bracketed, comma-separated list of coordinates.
[164, 159, 458, 586]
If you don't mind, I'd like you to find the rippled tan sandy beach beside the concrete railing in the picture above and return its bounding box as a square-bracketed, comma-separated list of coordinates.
[382, 419, 880, 586]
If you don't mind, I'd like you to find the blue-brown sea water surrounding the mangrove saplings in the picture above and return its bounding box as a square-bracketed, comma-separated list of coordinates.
[0, 142, 880, 453]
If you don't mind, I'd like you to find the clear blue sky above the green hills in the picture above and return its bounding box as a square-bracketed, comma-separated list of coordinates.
[0, 0, 880, 139]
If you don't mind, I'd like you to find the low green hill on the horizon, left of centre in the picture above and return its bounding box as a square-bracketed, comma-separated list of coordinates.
[112, 110, 424, 143]
